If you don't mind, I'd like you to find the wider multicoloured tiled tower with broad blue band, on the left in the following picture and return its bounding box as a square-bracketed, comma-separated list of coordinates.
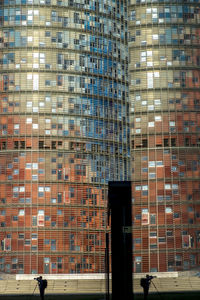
[0, 0, 129, 274]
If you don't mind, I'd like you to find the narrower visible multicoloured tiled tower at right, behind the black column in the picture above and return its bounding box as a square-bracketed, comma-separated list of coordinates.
[129, 0, 200, 272]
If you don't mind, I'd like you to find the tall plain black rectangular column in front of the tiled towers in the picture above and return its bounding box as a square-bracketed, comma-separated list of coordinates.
[108, 181, 133, 300]
